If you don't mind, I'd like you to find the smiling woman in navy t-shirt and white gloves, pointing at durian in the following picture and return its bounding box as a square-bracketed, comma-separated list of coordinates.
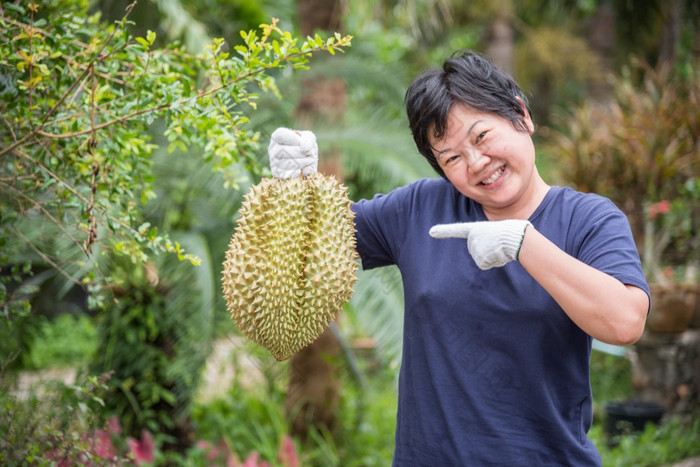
[270, 51, 649, 467]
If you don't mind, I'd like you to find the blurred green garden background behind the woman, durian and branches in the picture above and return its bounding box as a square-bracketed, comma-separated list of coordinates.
[0, 0, 700, 466]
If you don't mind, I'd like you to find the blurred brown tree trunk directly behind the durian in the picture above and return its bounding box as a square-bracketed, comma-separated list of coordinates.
[285, 0, 346, 438]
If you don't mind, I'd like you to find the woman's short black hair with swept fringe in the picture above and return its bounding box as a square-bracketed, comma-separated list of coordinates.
[404, 50, 532, 178]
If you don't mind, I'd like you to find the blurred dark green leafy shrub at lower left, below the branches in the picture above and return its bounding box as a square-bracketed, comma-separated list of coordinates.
[90, 261, 206, 449]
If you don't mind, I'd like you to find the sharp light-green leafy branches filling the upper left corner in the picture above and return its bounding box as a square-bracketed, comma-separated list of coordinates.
[0, 0, 351, 317]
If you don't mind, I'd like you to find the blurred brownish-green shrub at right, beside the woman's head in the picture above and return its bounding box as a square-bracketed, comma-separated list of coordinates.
[548, 57, 700, 257]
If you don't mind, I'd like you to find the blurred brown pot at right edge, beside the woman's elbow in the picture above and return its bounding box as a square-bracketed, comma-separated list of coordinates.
[646, 283, 698, 333]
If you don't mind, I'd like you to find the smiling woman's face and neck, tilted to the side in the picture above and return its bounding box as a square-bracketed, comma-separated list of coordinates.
[431, 105, 547, 220]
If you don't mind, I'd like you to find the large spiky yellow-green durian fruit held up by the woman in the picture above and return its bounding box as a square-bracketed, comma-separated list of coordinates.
[222, 173, 358, 361]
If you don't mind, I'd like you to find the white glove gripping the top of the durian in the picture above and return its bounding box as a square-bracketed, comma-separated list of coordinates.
[267, 128, 318, 179]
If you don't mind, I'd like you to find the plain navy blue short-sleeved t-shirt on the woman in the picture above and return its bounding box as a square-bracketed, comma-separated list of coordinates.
[352, 179, 648, 467]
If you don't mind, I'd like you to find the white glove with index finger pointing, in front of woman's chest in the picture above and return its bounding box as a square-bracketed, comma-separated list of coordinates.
[430, 219, 532, 269]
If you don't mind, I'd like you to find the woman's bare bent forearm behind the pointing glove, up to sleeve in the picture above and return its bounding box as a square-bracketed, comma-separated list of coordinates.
[518, 225, 649, 345]
